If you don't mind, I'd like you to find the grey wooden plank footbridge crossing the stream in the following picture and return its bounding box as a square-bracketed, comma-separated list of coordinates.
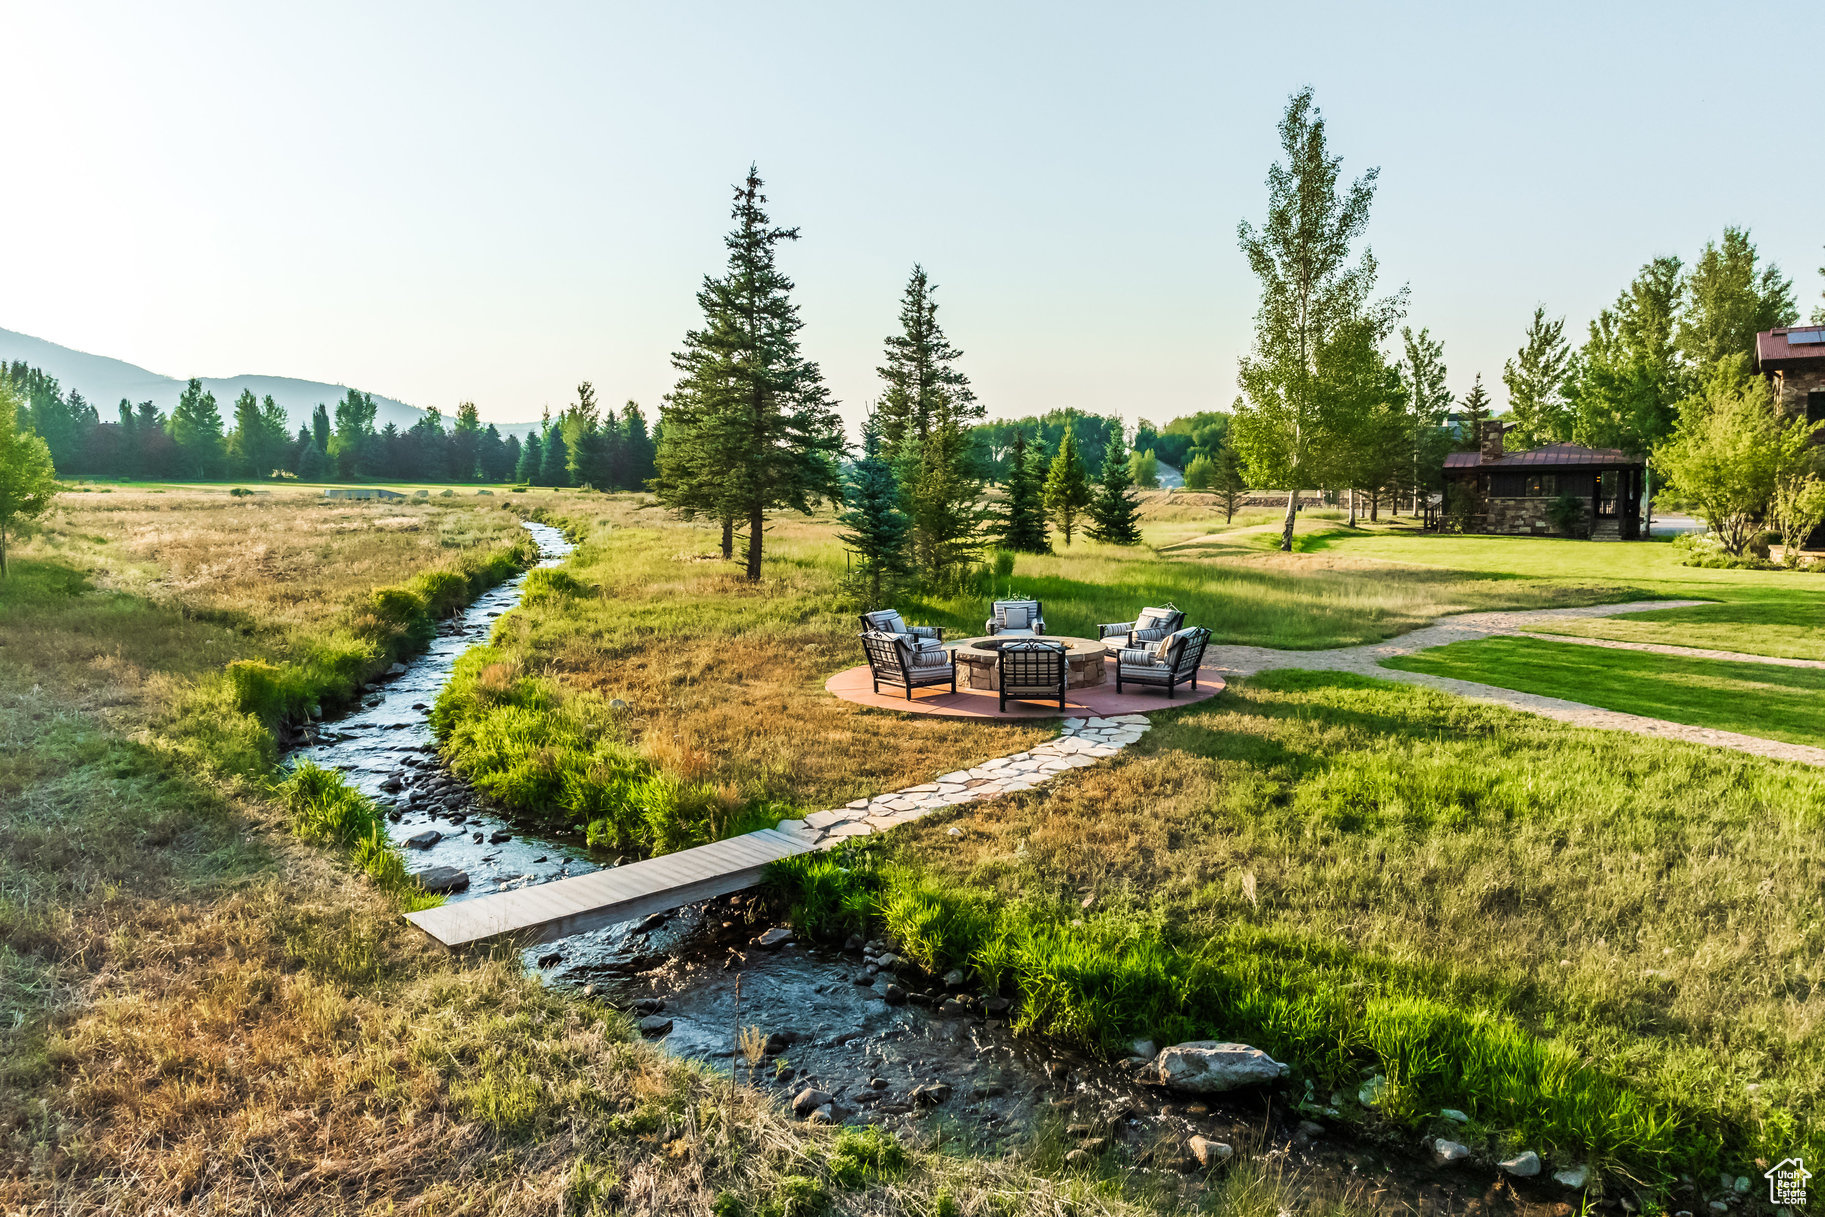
[405, 828, 816, 949]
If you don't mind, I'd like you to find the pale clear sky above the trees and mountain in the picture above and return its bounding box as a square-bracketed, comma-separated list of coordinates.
[0, 0, 1825, 432]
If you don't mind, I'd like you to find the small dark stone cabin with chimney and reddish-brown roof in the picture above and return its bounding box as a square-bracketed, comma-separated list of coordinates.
[1427, 420, 1648, 540]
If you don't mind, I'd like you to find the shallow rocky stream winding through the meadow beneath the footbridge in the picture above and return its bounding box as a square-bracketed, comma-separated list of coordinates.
[292, 522, 1575, 1217]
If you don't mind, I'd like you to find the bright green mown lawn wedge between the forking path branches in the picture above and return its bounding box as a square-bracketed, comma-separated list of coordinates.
[1385, 639, 1825, 748]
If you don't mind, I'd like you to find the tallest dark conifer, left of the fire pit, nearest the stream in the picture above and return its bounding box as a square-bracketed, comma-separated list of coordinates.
[655, 166, 843, 580]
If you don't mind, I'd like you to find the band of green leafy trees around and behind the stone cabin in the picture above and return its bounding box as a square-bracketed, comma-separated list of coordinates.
[1233, 89, 1825, 549]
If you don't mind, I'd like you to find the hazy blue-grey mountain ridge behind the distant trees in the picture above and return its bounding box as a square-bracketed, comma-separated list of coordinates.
[0, 330, 538, 436]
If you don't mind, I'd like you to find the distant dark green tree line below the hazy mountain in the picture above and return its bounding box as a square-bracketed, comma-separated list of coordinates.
[0, 363, 655, 491]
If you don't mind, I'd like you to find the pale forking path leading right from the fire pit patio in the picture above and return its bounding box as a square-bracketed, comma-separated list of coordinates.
[1205, 600, 1825, 766]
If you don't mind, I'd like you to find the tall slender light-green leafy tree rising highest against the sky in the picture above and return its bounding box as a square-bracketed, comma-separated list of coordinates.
[1232, 89, 1403, 551]
